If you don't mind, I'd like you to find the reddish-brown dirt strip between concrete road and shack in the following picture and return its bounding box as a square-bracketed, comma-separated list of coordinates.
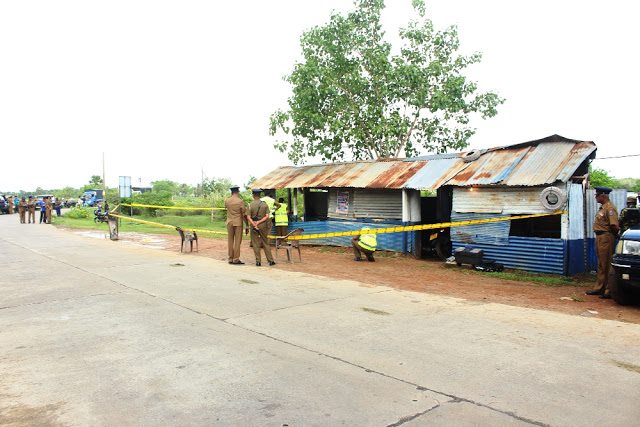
[76, 233, 640, 323]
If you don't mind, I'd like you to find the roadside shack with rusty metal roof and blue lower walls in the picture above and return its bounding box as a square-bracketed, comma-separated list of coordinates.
[254, 135, 626, 275]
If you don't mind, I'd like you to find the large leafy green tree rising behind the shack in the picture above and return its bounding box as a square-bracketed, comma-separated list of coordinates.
[270, 0, 504, 164]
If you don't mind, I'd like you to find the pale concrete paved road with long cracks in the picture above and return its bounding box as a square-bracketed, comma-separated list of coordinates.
[0, 215, 640, 427]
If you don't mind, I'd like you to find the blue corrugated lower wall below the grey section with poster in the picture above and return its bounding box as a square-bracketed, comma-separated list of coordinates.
[289, 220, 416, 252]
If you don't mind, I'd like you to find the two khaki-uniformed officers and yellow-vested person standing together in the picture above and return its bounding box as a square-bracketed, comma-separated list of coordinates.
[224, 186, 289, 267]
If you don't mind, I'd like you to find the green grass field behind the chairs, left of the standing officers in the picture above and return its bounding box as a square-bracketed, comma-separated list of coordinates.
[53, 215, 227, 238]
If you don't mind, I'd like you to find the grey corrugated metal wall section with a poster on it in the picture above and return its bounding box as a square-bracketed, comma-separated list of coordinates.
[328, 188, 402, 220]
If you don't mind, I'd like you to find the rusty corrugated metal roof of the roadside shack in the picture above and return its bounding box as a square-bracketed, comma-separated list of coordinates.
[254, 135, 596, 190]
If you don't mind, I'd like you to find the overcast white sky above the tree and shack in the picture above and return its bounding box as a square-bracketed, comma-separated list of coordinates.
[0, 0, 640, 192]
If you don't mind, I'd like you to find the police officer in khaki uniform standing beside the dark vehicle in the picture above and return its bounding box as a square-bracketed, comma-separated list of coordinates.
[586, 187, 620, 299]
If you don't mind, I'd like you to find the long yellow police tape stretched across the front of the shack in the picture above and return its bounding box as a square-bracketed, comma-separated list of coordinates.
[109, 205, 567, 240]
